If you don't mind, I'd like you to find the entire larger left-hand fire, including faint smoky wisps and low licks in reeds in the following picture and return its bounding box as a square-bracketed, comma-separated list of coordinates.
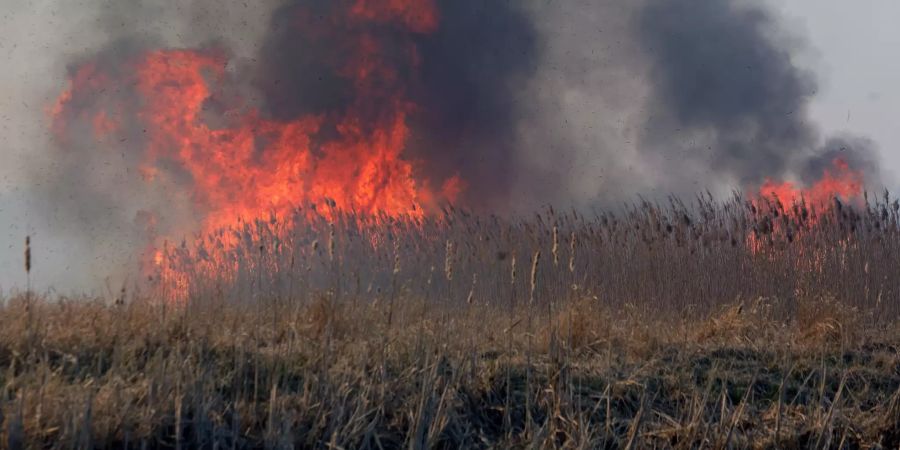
[48, 0, 465, 288]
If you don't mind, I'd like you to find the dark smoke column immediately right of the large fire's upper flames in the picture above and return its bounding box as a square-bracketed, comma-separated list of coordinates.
[413, 0, 540, 208]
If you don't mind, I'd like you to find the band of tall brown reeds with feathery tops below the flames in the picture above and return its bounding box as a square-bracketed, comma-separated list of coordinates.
[158, 195, 900, 320]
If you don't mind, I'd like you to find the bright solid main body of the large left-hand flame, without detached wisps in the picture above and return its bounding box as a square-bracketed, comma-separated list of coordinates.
[126, 51, 435, 231]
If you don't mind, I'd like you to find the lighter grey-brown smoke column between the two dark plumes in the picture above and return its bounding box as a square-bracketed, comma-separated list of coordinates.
[510, 0, 652, 207]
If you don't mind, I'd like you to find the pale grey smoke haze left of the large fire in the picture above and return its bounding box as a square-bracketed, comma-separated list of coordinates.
[0, 0, 282, 292]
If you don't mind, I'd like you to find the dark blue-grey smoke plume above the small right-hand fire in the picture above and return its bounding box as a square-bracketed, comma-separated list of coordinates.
[637, 0, 875, 187]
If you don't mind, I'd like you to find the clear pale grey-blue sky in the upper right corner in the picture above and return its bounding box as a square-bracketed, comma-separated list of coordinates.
[773, 0, 900, 183]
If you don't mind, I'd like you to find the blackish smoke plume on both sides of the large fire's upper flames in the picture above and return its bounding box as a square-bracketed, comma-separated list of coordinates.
[251, 0, 539, 207]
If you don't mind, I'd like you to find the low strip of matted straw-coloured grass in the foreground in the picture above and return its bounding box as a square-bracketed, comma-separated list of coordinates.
[0, 298, 900, 448]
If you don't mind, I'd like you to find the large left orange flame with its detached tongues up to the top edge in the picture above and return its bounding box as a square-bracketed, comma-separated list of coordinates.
[50, 5, 461, 231]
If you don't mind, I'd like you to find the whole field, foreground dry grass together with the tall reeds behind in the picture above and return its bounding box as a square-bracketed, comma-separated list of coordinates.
[0, 197, 900, 448]
